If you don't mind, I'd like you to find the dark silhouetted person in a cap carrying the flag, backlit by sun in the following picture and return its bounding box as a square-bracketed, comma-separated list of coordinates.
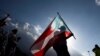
[53, 26, 70, 56]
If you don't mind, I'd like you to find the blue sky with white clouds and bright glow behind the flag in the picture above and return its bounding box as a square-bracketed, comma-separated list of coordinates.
[0, 0, 100, 56]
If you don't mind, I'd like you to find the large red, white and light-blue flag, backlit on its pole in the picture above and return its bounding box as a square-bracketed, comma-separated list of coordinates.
[31, 13, 73, 56]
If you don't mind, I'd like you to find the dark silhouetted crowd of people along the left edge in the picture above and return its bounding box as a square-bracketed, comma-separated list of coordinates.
[0, 14, 26, 56]
